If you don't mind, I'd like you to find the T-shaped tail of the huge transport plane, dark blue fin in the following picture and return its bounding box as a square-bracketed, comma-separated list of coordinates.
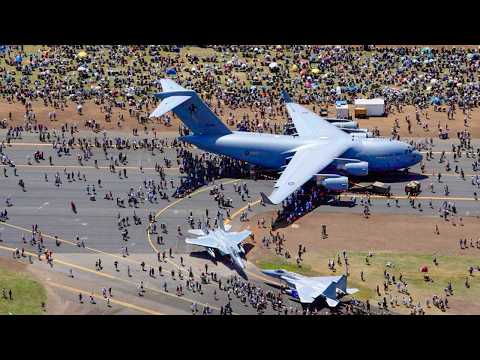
[150, 79, 232, 135]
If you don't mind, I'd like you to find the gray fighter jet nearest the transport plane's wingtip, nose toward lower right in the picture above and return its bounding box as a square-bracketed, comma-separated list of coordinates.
[185, 219, 252, 271]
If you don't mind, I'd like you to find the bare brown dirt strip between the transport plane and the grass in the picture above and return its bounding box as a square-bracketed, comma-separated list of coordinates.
[244, 211, 480, 258]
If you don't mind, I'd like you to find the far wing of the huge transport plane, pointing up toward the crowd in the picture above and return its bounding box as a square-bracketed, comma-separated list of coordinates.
[283, 91, 348, 139]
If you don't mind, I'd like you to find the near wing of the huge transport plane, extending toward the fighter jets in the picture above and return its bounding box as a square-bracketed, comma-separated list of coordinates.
[261, 140, 349, 205]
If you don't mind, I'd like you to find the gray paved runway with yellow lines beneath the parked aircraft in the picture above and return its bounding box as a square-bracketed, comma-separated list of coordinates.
[0, 132, 480, 315]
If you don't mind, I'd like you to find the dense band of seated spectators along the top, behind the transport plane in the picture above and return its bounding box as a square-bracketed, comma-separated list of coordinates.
[0, 45, 480, 137]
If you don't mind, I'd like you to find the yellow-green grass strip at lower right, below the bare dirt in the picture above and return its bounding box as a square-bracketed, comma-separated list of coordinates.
[251, 252, 480, 314]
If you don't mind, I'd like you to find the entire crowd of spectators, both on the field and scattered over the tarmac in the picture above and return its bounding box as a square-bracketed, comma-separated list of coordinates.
[0, 46, 480, 314]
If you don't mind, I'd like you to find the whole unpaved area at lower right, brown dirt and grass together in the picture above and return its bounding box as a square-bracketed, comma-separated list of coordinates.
[245, 211, 480, 314]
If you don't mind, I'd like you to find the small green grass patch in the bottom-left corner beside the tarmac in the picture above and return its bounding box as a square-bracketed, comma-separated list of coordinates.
[0, 268, 47, 315]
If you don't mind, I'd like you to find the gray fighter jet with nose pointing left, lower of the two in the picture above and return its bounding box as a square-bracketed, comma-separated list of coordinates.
[262, 269, 358, 307]
